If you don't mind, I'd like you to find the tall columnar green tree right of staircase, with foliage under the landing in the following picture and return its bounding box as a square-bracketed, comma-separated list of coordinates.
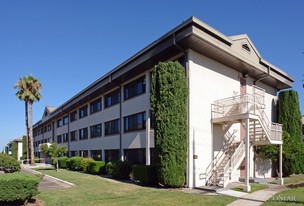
[257, 90, 304, 176]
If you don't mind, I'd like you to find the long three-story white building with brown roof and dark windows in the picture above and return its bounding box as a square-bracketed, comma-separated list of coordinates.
[34, 17, 293, 190]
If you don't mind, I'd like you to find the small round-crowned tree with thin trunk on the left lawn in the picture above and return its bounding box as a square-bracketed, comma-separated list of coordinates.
[40, 143, 67, 172]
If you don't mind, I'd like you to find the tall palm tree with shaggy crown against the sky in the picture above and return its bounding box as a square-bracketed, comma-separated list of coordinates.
[15, 75, 42, 165]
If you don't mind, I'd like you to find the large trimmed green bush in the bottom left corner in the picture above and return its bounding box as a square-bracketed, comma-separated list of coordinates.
[0, 172, 39, 205]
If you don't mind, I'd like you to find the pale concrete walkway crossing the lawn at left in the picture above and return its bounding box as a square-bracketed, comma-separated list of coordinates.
[21, 166, 74, 191]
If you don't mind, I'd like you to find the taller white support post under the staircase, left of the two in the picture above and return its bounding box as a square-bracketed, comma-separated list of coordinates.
[243, 118, 251, 192]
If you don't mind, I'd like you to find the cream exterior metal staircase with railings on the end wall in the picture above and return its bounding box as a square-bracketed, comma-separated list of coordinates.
[203, 86, 282, 187]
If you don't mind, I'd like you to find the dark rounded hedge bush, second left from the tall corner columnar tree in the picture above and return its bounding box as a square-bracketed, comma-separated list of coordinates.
[106, 160, 132, 179]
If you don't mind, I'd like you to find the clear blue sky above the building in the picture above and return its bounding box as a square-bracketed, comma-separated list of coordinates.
[0, 0, 304, 150]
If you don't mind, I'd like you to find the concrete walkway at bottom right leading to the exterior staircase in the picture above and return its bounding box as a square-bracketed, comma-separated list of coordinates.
[225, 185, 287, 206]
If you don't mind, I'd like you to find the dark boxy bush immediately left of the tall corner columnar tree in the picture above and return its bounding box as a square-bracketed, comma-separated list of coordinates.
[132, 165, 157, 184]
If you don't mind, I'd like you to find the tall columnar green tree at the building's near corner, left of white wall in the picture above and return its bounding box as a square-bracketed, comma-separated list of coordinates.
[150, 61, 188, 187]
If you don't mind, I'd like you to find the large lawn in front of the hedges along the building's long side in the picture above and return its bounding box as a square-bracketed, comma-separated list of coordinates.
[36, 170, 236, 206]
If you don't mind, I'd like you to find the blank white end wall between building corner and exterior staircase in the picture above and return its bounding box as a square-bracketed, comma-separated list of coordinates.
[188, 50, 240, 187]
